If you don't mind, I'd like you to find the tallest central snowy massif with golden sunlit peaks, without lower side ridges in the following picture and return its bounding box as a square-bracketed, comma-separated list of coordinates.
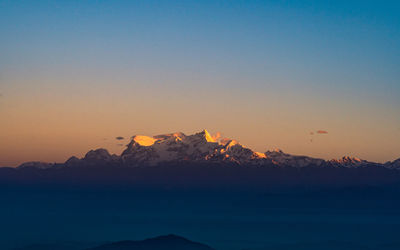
[121, 130, 266, 165]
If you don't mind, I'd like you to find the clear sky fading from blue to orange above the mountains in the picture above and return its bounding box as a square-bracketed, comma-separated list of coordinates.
[0, 0, 400, 166]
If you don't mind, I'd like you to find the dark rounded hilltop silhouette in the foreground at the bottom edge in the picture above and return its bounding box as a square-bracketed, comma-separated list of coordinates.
[88, 235, 212, 250]
